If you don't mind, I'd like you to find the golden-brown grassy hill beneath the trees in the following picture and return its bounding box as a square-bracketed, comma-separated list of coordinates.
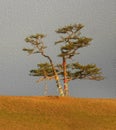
[0, 96, 116, 130]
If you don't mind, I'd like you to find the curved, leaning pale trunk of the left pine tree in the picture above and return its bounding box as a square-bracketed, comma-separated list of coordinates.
[41, 53, 64, 96]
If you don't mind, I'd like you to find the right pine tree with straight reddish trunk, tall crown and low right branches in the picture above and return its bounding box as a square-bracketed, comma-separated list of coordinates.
[55, 24, 103, 96]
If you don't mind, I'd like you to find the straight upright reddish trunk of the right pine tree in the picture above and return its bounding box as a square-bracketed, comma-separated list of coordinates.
[63, 57, 69, 96]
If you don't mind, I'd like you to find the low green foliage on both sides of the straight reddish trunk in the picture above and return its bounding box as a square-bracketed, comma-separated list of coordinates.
[56, 62, 104, 81]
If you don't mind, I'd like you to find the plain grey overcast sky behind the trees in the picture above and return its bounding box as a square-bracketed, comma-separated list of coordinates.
[0, 0, 116, 98]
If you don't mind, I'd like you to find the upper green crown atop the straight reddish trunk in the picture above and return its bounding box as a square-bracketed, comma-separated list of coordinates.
[55, 24, 92, 58]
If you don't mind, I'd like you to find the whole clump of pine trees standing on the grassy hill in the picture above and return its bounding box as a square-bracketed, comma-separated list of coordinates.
[23, 24, 103, 96]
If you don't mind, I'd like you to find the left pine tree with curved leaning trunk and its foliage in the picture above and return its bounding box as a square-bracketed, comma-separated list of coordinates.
[23, 34, 64, 96]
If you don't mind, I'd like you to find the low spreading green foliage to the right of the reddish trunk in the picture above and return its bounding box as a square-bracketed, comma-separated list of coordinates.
[68, 63, 104, 80]
